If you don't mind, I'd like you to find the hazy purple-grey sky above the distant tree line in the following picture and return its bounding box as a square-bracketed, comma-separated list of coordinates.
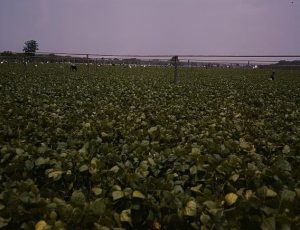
[0, 0, 300, 55]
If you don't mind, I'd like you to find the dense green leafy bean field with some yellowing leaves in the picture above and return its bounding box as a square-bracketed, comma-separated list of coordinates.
[0, 64, 300, 230]
